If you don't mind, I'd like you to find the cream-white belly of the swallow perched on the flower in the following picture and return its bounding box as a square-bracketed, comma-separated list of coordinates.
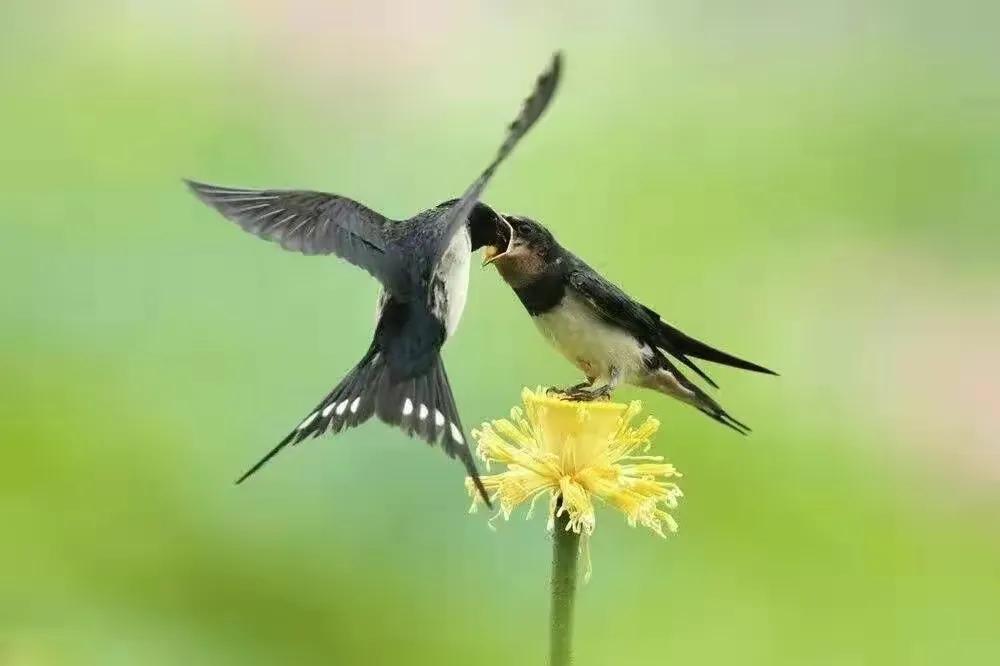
[532, 294, 645, 383]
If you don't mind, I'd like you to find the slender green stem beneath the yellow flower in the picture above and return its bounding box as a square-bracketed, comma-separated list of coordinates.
[549, 501, 580, 666]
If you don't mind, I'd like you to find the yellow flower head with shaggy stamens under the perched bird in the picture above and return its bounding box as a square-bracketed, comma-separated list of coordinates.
[465, 388, 682, 536]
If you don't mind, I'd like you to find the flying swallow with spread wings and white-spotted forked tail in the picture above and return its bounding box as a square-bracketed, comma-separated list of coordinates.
[186, 52, 562, 499]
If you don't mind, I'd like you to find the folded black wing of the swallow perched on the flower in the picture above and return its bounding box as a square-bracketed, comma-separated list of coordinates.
[569, 257, 777, 388]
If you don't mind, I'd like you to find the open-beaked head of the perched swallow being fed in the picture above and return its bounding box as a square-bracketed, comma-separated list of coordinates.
[483, 215, 558, 287]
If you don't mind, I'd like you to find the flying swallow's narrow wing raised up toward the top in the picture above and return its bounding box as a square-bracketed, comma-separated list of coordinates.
[433, 52, 562, 263]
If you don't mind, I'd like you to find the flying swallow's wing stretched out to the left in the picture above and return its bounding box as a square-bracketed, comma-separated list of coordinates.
[186, 180, 399, 287]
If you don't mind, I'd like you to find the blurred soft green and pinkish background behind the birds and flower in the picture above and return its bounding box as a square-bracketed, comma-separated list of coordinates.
[0, 0, 1000, 666]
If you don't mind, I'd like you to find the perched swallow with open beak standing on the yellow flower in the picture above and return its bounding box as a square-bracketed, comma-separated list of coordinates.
[483, 215, 777, 435]
